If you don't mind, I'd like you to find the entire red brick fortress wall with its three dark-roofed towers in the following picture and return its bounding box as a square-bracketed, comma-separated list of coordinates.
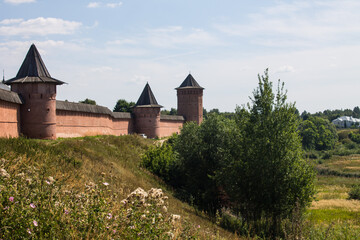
[0, 44, 203, 139]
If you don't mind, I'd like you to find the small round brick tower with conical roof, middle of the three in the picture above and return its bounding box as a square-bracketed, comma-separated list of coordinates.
[133, 83, 162, 138]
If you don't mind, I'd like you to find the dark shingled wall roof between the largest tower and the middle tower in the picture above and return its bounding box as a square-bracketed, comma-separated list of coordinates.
[56, 100, 131, 119]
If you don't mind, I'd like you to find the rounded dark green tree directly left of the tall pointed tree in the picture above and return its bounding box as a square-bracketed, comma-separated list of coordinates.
[175, 114, 237, 214]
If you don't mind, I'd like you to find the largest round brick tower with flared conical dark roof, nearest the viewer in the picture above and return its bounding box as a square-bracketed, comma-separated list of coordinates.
[5, 44, 64, 139]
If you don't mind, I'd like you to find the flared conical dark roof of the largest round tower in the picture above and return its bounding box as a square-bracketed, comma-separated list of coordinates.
[5, 44, 64, 85]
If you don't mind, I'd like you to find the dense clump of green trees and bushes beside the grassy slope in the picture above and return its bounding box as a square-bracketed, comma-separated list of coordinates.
[143, 71, 315, 237]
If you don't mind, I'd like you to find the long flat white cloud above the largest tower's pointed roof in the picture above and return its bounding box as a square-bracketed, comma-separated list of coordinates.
[0, 17, 82, 37]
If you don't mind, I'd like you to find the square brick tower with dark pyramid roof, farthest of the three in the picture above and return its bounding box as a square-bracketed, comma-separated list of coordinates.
[176, 74, 204, 124]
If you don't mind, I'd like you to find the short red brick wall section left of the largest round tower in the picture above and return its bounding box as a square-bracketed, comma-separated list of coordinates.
[0, 99, 20, 138]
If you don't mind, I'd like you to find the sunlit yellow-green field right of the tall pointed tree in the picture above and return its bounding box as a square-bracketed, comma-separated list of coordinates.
[307, 154, 360, 227]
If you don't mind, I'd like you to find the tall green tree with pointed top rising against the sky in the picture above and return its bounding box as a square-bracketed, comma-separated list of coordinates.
[218, 70, 314, 236]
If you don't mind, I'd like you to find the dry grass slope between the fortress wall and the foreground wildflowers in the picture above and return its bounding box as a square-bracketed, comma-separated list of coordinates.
[0, 135, 236, 239]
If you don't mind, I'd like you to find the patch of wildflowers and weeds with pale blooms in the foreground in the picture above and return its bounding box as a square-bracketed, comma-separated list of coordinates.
[0, 158, 197, 239]
